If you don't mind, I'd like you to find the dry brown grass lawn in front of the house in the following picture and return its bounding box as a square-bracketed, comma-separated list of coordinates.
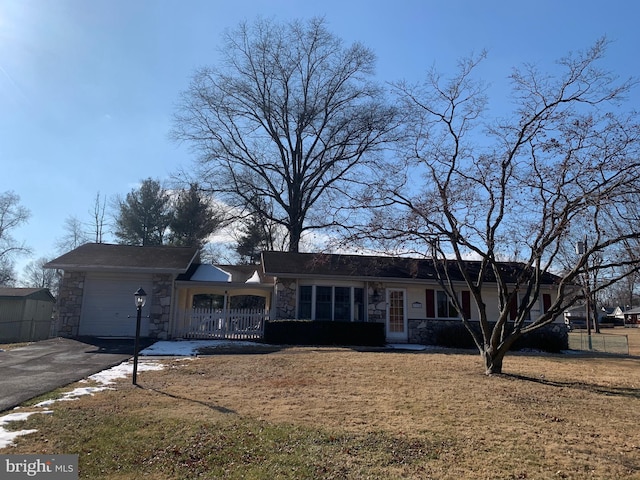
[0, 331, 640, 479]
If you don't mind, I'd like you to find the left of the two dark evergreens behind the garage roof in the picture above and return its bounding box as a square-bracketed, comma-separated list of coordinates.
[115, 178, 171, 246]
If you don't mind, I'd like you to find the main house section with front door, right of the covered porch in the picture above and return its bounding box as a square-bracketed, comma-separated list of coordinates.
[262, 252, 562, 344]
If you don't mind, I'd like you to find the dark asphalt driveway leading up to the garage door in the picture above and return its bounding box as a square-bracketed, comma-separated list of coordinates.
[0, 338, 152, 412]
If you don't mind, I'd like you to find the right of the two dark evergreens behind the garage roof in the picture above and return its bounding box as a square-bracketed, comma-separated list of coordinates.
[169, 183, 223, 248]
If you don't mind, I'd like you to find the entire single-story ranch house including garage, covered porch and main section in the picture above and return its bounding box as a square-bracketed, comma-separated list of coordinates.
[46, 244, 563, 344]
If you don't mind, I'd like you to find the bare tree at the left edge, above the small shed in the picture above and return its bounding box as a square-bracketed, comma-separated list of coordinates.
[0, 191, 31, 285]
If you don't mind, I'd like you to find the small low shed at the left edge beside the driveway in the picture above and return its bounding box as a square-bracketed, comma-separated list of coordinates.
[0, 288, 56, 343]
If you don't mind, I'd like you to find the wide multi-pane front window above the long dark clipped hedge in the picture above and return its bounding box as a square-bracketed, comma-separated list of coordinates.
[298, 285, 365, 322]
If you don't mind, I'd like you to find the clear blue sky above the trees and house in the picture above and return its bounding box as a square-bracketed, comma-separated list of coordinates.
[0, 0, 640, 278]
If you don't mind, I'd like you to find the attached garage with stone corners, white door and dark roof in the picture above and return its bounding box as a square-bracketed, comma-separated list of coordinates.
[45, 243, 198, 339]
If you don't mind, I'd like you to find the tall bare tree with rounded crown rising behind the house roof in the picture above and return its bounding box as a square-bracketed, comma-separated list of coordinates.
[173, 19, 396, 251]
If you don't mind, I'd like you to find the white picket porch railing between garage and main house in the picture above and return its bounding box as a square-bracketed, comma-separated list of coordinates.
[177, 308, 269, 340]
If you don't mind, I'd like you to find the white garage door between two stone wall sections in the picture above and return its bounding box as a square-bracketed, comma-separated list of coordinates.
[79, 273, 152, 337]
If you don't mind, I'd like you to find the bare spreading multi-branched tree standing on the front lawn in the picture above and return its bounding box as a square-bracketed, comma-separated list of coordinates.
[352, 39, 640, 374]
